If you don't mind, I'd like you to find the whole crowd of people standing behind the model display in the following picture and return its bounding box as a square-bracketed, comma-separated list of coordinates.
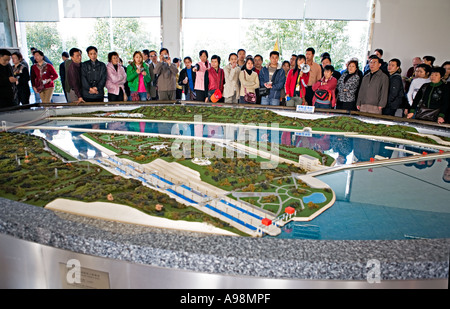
[0, 46, 450, 123]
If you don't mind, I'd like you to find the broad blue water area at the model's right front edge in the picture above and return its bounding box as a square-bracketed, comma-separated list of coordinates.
[277, 159, 450, 240]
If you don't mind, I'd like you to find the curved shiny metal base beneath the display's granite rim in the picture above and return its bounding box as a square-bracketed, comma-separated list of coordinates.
[0, 235, 448, 289]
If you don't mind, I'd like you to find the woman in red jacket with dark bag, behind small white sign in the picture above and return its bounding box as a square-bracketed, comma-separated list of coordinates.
[312, 65, 337, 108]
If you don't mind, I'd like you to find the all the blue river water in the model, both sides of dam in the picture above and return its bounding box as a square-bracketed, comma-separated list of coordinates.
[23, 120, 450, 240]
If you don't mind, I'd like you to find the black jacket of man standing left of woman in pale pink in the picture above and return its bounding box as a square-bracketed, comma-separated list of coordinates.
[81, 60, 106, 101]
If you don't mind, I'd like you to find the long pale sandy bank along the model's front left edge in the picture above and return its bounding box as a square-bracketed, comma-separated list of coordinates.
[45, 199, 237, 236]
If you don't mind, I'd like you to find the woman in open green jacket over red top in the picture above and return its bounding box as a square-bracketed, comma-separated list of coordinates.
[127, 51, 151, 101]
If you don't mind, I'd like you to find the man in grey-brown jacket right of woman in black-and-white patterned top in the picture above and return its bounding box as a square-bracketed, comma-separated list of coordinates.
[356, 55, 389, 114]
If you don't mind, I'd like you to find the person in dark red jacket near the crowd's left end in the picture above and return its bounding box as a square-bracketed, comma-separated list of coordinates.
[31, 50, 58, 103]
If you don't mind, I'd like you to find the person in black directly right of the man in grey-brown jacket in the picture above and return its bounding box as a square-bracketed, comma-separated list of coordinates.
[382, 58, 405, 116]
